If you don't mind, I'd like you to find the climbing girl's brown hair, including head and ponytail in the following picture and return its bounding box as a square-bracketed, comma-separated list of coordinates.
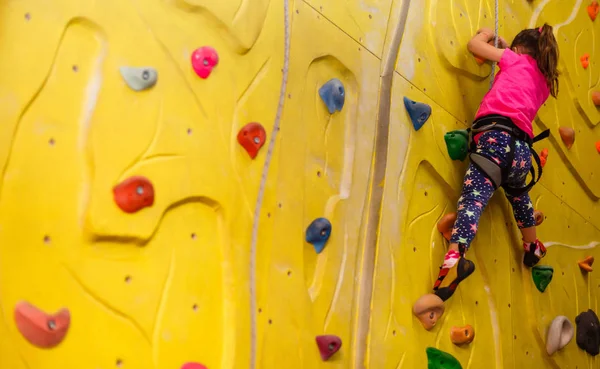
[510, 23, 559, 97]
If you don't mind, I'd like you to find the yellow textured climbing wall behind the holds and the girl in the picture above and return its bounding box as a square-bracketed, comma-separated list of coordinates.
[0, 0, 600, 369]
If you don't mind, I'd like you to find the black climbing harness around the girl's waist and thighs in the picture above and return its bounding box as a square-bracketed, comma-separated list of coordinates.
[467, 115, 550, 196]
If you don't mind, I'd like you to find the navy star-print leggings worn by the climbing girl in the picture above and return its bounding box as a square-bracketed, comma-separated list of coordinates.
[450, 130, 535, 249]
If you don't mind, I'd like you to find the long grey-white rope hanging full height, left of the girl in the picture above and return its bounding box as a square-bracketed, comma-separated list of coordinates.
[249, 0, 290, 369]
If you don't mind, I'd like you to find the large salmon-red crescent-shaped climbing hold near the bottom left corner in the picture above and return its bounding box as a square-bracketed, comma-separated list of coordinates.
[14, 302, 71, 348]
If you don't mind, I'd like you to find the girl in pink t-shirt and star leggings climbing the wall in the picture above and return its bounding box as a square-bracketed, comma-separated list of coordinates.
[433, 24, 558, 301]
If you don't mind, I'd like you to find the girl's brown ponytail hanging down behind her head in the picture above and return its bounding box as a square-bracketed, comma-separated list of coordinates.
[535, 23, 559, 97]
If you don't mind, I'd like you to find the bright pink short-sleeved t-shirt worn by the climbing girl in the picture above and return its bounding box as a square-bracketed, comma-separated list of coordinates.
[475, 49, 550, 138]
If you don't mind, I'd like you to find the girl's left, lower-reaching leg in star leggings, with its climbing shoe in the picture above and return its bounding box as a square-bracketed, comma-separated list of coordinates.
[433, 164, 494, 301]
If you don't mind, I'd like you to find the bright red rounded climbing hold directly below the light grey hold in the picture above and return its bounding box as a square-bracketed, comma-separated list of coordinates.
[113, 176, 154, 213]
